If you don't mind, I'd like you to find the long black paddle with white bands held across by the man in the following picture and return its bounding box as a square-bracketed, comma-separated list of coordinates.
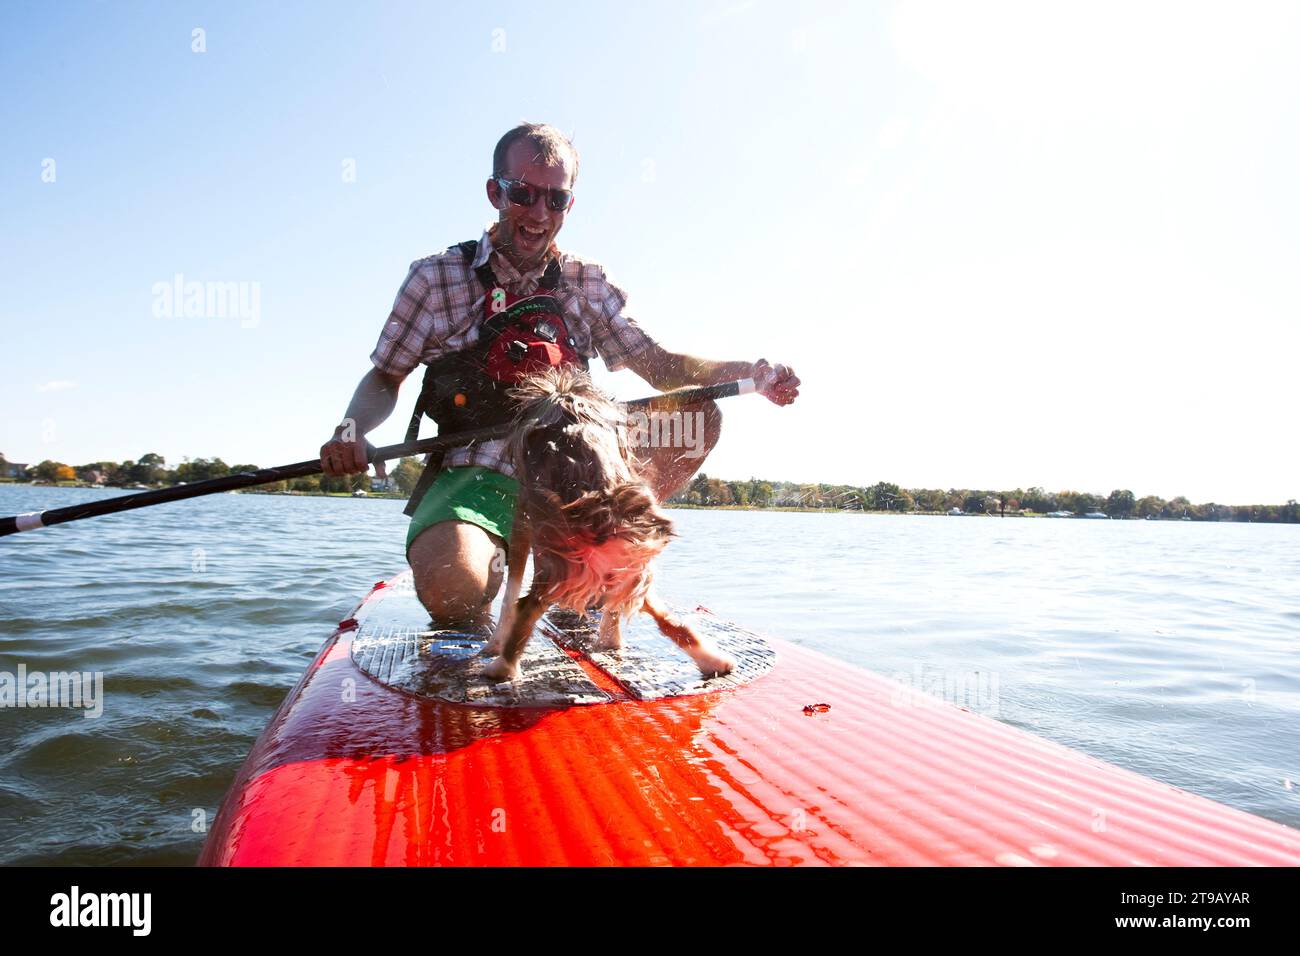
[0, 378, 755, 537]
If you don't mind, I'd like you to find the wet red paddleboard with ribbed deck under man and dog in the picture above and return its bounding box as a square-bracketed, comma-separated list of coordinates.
[199, 574, 1300, 866]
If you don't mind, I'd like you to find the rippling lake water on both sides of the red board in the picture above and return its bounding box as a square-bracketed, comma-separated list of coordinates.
[0, 485, 1300, 865]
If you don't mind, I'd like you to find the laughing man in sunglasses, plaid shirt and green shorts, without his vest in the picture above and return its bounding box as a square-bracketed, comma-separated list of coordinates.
[321, 124, 800, 628]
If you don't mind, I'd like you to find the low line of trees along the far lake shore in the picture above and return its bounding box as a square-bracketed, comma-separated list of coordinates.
[0, 453, 1300, 523]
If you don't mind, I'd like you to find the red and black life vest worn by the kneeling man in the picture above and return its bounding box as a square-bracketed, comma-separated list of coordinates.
[404, 239, 588, 515]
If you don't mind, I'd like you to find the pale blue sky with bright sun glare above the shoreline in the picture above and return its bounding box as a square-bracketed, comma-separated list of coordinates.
[0, 0, 1300, 503]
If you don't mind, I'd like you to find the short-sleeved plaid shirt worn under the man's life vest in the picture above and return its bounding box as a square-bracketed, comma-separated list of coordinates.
[371, 226, 655, 477]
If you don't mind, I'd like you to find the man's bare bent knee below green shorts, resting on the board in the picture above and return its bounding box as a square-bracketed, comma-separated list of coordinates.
[407, 522, 506, 630]
